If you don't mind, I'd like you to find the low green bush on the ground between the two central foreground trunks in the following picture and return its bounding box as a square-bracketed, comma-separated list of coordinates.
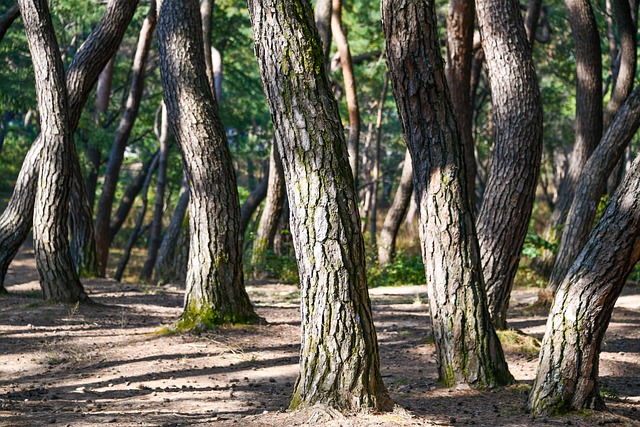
[367, 251, 425, 288]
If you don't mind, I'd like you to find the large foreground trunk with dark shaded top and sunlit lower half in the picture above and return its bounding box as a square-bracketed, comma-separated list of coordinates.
[382, 0, 513, 388]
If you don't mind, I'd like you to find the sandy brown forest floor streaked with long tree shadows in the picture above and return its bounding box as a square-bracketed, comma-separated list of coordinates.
[0, 246, 640, 427]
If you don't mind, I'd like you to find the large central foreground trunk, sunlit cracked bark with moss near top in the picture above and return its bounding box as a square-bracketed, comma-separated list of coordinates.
[247, 0, 391, 410]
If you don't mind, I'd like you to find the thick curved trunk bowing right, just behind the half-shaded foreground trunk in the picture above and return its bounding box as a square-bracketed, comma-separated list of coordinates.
[476, 0, 542, 329]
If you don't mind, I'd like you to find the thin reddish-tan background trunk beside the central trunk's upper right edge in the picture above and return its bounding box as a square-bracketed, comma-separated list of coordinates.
[331, 0, 361, 187]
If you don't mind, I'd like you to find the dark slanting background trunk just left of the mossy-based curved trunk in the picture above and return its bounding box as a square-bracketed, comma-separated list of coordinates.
[153, 182, 189, 285]
